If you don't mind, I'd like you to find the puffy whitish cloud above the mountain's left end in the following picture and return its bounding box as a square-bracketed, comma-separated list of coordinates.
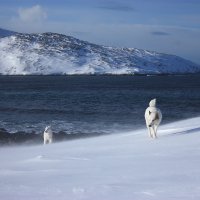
[18, 5, 47, 22]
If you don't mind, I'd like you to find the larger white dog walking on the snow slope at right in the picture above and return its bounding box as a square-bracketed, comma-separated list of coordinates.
[144, 99, 162, 138]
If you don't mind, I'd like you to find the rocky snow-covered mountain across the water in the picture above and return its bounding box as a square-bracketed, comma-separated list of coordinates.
[0, 29, 200, 75]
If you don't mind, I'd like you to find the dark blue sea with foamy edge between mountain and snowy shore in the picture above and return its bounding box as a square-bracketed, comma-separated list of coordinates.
[0, 75, 200, 134]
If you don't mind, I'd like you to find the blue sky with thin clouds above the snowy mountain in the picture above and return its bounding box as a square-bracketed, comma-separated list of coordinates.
[0, 0, 200, 64]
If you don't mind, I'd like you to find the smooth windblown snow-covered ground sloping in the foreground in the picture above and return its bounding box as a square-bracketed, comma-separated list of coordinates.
[0, 117, 200, 200]
